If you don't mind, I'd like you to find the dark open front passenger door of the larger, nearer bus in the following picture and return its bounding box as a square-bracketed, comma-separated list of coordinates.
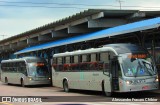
[110, 58, 120, 91]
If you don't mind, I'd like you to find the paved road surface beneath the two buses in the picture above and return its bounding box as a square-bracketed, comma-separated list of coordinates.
[0, 82, 160, 105]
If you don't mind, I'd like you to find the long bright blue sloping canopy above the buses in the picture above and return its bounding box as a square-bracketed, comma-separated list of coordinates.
[14, 17, 160, 55]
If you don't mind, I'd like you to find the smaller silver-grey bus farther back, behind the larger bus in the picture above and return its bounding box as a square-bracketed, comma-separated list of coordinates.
[1, 57, 51, 87]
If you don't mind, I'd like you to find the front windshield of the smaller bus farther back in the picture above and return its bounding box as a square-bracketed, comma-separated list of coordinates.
[28, 63, 49, 77]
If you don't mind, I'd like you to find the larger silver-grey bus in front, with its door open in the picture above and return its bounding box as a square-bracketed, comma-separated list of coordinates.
[52, 44, 159, 96]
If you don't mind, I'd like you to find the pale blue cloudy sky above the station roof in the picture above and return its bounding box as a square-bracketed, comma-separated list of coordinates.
[0, 0, 160, 40]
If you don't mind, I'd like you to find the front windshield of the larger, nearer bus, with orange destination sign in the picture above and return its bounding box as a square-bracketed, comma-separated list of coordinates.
[120, 53, 156, 77]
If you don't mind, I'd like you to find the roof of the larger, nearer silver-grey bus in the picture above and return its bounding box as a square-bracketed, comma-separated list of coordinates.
[53, 43, 147, 57]
